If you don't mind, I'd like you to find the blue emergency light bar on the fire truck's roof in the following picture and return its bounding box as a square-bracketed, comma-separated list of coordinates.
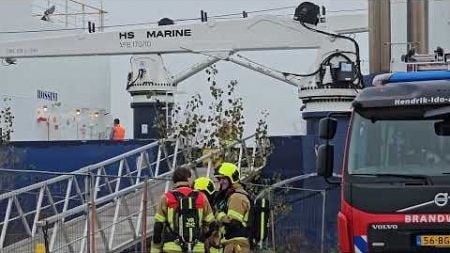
[387, 71, 450, 83]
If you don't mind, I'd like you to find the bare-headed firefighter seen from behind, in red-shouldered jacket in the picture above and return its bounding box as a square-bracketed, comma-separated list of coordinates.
[150, 167, 214, 253]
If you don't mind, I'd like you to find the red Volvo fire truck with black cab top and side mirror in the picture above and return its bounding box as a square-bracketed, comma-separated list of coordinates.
[317, 71, 450, 253]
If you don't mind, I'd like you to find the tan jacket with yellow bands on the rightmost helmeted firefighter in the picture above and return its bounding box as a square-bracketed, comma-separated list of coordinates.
[216, 183, 251, 245]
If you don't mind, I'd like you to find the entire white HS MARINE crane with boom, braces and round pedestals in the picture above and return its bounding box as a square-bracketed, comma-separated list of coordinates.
[0, 2, 368, 138]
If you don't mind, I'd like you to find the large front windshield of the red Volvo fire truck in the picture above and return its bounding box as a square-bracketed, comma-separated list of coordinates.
[348, 113, 450, 176]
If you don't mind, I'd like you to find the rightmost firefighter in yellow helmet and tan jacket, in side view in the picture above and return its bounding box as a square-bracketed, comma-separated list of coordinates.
[215, 162, 251, 253]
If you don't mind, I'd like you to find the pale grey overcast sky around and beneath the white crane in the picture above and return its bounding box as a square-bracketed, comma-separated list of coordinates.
[103, 0, 368, 135]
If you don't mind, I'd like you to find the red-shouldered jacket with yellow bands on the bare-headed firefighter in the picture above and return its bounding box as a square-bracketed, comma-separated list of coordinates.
[151, 182, 214, 252]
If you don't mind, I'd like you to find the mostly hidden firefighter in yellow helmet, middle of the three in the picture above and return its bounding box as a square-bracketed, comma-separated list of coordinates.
[194, 177, 223, 253]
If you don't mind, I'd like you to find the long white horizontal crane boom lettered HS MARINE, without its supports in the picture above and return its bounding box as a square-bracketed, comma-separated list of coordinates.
[0, 14, 367, 58]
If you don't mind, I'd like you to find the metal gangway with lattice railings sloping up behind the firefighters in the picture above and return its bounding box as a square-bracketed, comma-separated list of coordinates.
[0, 135, 267, 253]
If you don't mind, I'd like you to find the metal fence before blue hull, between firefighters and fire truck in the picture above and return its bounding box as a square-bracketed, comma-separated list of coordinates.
[248, 183, 337, 253]
